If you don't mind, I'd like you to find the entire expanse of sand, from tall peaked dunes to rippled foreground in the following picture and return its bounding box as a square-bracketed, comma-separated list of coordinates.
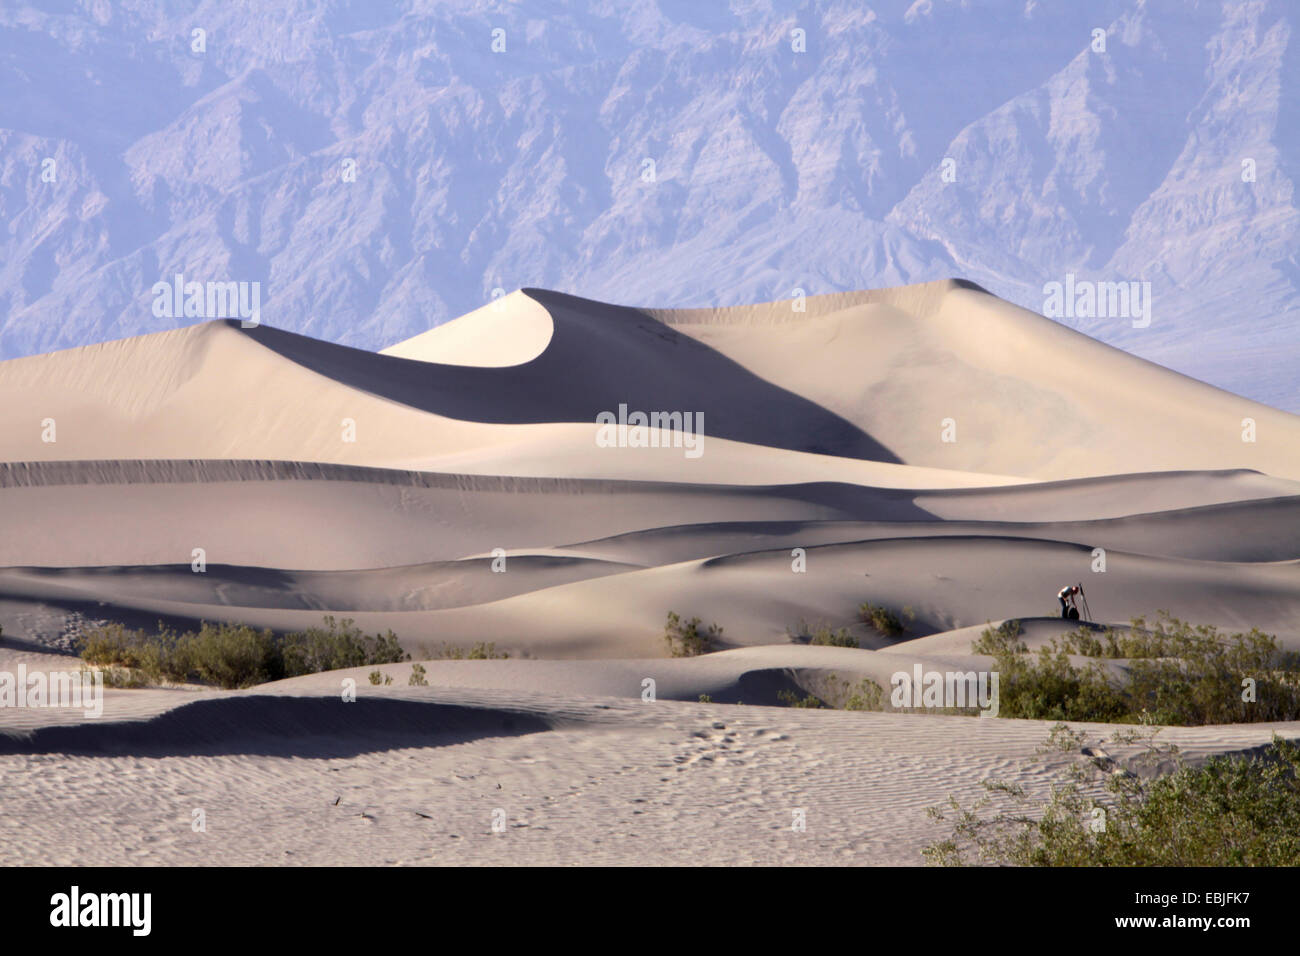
[0, 281, 1300, 864]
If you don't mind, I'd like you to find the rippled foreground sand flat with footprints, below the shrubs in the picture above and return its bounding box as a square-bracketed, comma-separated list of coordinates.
[0, 662, 1300, 865]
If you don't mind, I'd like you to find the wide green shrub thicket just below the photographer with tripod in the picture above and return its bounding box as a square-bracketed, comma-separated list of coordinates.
[971, 611, 1300, 724]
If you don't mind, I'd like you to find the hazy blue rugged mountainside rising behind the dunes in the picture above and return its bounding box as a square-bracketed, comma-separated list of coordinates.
[0, 0, 1300, 411]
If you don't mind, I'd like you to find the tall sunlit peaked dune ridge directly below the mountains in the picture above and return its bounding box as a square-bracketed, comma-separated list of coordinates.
[0, 282, 1300, 481]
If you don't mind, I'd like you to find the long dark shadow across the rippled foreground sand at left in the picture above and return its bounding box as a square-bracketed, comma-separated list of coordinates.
[0, 695, 551, 758]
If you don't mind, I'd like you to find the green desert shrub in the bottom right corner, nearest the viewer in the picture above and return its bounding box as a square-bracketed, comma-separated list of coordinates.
[923, 727, 1300, 866]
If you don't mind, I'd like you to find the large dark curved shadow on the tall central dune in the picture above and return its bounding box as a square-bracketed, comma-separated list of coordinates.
[230, 289, 901, 463]
